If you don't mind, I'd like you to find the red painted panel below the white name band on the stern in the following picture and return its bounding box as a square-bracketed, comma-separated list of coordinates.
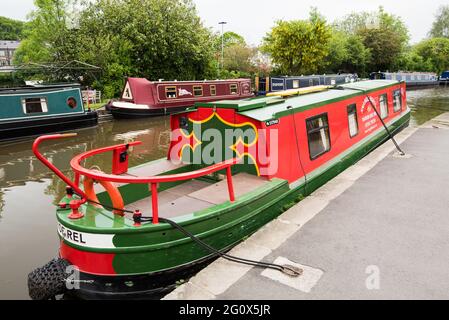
[59, 241, 117, 276]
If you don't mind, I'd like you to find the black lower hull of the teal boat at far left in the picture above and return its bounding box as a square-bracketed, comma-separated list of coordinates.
[0, 112, 98, 141]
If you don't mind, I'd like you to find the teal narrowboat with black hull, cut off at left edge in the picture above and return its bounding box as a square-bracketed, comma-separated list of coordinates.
[0, 84, 98, 140]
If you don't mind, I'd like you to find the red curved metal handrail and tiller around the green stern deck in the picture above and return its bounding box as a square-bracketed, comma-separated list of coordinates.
[33, 133, 239, 224]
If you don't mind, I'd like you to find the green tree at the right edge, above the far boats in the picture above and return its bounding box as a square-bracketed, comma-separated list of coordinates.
[416, 38, 449, 74]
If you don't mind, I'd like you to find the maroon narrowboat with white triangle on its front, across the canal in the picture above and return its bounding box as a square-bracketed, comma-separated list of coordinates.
[110, 78, 253, 119]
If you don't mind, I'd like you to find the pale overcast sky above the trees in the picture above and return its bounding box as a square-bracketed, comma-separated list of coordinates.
[0, 0, 449, 45]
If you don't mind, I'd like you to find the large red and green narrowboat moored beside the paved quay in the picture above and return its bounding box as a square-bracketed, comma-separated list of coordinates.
[30, 80, 410, 298]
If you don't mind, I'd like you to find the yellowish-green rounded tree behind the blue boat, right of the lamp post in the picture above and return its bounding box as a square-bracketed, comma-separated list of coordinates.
[262, 9, 331, 74]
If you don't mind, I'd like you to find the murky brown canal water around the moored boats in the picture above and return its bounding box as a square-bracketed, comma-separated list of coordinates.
[0, 88, 449, 299]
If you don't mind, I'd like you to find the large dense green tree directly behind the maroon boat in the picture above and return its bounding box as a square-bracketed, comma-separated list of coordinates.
[75, 0, 214, 96]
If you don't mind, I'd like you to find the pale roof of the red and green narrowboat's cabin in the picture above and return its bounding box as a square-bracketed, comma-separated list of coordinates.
[195, 80, 401, 121]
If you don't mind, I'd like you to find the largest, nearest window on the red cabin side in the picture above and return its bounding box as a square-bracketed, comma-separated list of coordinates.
[306, 113, 331, 160]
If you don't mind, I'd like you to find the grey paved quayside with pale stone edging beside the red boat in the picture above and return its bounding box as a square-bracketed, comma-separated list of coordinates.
[165, 113, 449, 300]
